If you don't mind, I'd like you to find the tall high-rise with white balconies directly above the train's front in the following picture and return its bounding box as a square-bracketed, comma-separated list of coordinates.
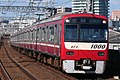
[72, 0, 109, 17]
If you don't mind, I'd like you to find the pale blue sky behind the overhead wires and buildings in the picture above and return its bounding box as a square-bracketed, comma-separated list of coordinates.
[0, 0, 120, 16]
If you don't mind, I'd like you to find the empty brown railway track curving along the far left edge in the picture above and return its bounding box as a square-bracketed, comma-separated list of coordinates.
[1, 39, 37, 80]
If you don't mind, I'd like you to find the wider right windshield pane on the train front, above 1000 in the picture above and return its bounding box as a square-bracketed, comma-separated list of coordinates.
[78, 25, 108, 42]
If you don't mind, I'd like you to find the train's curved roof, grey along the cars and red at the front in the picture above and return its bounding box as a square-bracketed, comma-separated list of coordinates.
[11, 12, 107, 34]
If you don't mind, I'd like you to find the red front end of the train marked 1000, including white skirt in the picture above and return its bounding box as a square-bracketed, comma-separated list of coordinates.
[60, 14, 108, 74]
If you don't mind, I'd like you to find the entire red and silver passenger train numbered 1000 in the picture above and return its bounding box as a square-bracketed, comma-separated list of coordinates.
[10, 13, 108, 74]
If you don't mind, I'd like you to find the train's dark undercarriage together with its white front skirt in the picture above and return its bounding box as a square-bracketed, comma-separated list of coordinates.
[11, 45, 106, 74]
